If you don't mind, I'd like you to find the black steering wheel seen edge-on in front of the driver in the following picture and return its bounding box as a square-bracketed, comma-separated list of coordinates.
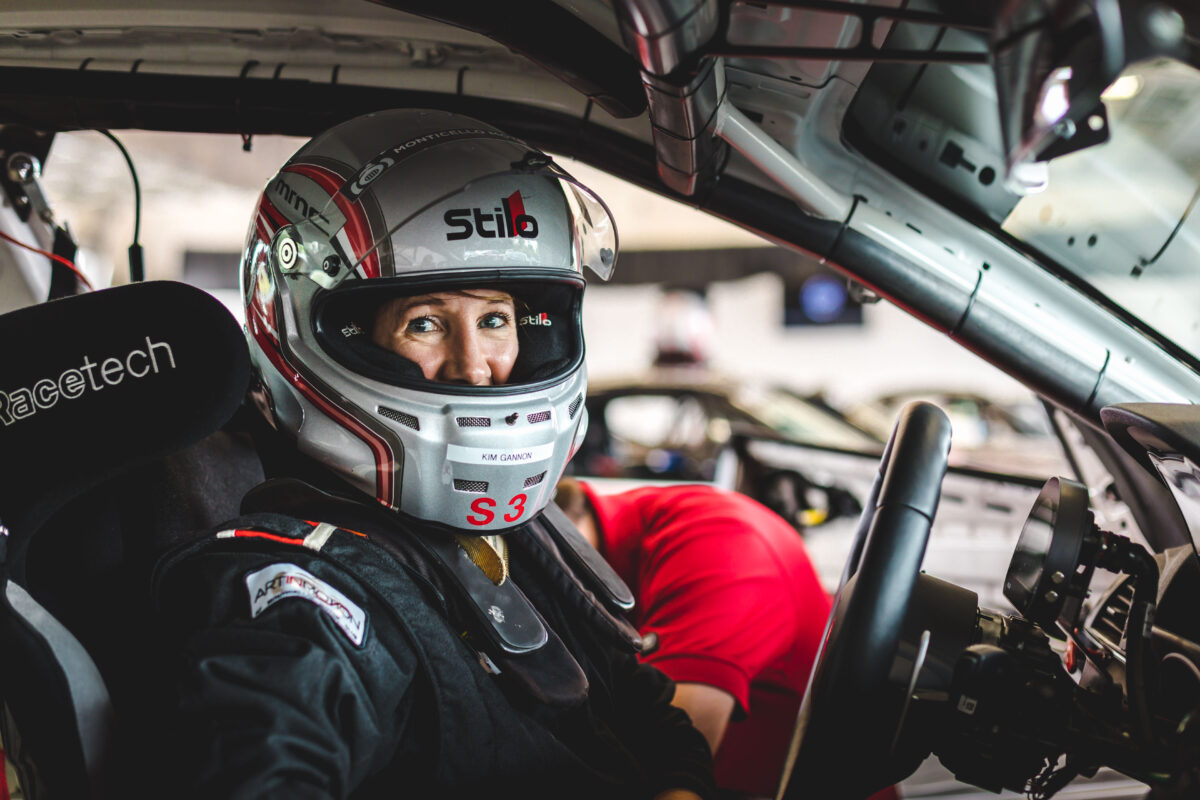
[782, 402, 950, 800]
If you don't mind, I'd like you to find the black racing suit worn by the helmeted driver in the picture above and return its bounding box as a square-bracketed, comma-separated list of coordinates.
[154, 479, 712, 799]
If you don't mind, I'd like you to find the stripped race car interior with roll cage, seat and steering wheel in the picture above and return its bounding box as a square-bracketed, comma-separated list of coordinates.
[0, 0, 1200, 800]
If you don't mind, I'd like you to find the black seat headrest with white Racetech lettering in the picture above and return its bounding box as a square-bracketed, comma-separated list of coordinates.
[0, 281, 250, 545]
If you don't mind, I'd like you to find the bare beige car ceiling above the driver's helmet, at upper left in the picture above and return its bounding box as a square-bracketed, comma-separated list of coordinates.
[0, 0, 644, 145]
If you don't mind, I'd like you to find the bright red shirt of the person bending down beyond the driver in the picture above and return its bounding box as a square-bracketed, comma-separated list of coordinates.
[584, 486, 830, 795]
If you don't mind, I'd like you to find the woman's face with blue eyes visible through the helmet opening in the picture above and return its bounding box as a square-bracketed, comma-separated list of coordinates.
[371, 289, 517, 386]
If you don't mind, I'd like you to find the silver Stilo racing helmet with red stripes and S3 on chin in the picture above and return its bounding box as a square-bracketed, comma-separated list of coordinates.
[240, 109, 617, 534]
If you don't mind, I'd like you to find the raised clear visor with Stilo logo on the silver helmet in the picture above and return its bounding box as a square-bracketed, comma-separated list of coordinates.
[274, 159, 618, 289]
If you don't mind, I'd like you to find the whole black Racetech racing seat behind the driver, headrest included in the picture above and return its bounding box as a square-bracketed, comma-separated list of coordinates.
[0, 282, 255, 799]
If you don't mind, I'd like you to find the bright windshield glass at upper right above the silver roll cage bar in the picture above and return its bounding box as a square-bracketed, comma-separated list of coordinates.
[1003, 60, 1200, 356]
